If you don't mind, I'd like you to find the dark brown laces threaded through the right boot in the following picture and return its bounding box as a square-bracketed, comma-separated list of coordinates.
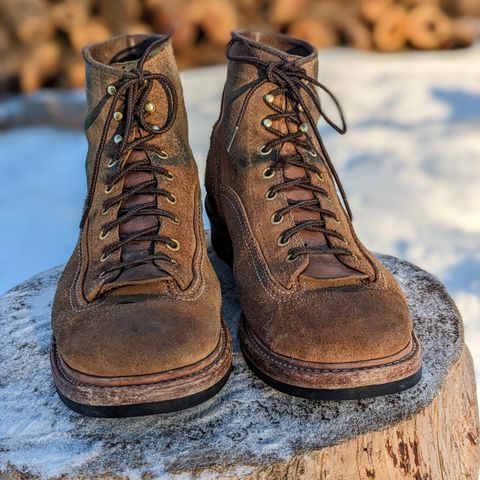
[227, 38, 352, 260]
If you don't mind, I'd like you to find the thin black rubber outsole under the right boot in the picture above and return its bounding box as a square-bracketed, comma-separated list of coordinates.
[242, 347, 422, 400]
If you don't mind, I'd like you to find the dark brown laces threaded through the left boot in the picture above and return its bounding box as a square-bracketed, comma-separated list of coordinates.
[81, 39, 178, 277]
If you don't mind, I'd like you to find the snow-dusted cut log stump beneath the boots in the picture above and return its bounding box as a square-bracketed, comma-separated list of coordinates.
[0, 252, 479, 480]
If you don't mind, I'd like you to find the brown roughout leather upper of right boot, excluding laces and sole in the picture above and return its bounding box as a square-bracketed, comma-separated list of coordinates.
[206, 32, 412, 363]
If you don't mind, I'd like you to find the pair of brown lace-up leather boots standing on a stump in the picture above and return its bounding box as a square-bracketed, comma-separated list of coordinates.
[51, 32, 421, 416]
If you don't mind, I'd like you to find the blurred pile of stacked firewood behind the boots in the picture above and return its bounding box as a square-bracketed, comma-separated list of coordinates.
[0, 0, 480, 94]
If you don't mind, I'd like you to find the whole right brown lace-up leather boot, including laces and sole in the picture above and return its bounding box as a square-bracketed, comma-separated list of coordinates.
[206, 32, 421, 399]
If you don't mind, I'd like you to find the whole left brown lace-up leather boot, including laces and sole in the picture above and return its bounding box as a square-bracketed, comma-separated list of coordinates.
[51, 35, 232, 416]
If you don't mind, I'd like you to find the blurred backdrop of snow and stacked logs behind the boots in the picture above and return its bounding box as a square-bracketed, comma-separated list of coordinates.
[0, 0, 480, 390]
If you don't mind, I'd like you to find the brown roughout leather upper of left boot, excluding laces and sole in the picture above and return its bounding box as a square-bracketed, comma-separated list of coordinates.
[52, 35, 221, 377]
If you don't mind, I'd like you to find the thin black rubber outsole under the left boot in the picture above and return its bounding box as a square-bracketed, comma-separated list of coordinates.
[56, 368, 232, 418]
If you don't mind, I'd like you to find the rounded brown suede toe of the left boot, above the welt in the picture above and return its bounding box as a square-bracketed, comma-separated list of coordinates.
[56, 295, 220, 377]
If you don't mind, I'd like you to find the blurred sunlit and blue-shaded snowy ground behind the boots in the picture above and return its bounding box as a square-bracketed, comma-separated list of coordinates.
[0, 46, 480, 390]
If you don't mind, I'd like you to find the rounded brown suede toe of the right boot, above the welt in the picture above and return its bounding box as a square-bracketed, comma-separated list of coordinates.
[247, 285, 412, 363]
